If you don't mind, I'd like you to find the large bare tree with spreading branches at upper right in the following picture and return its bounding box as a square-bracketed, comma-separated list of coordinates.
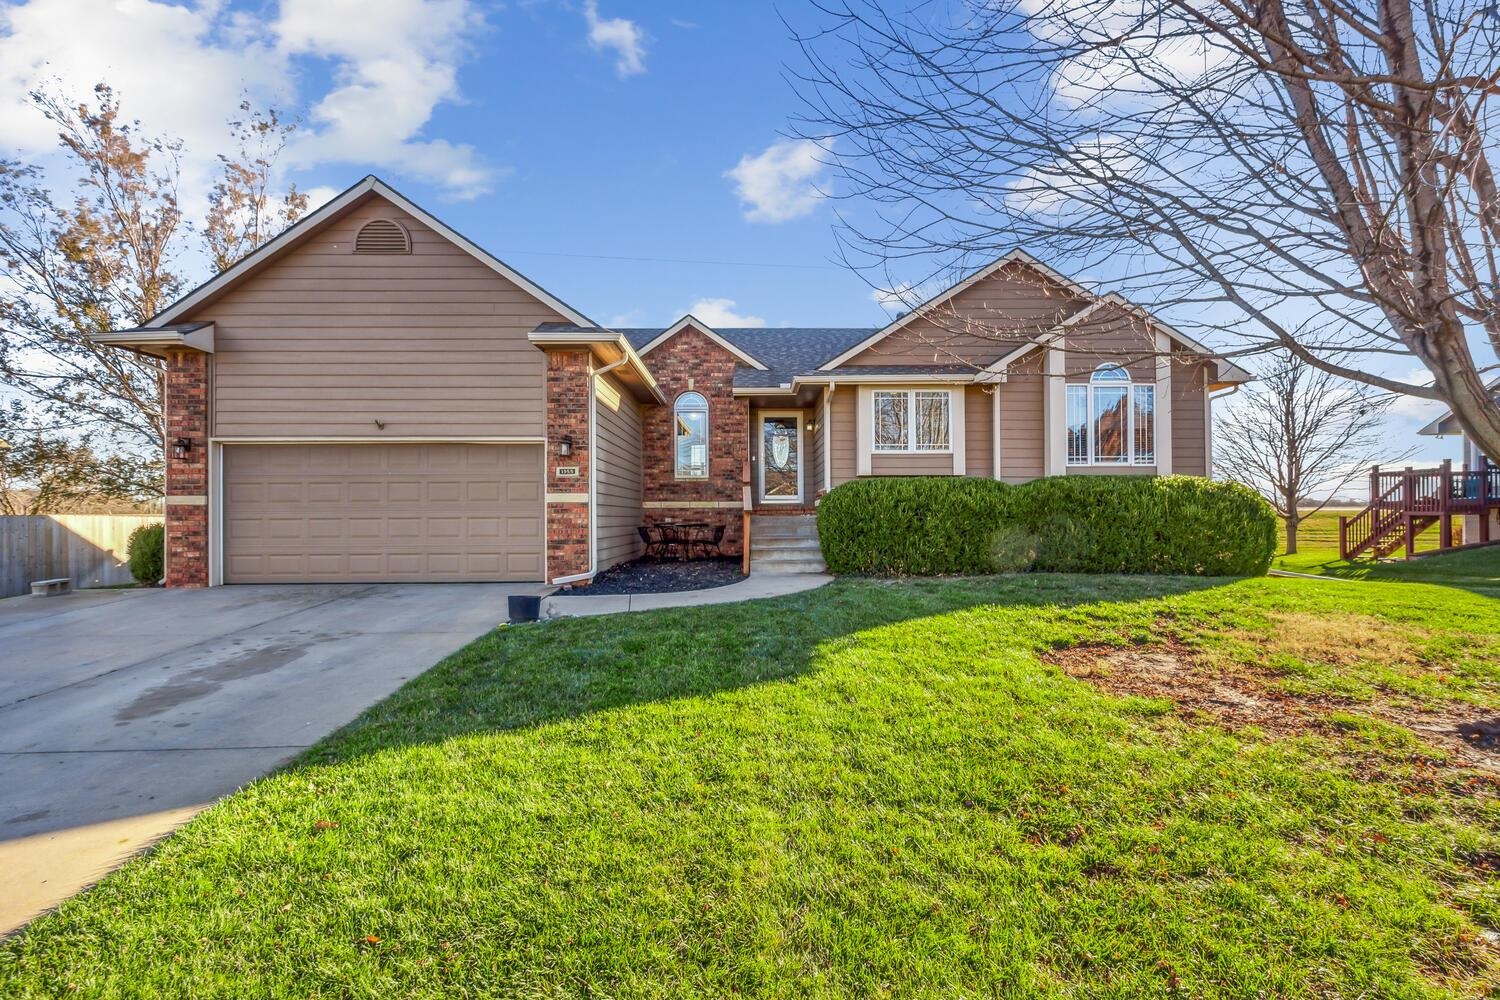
[794, 0, 1500, 456]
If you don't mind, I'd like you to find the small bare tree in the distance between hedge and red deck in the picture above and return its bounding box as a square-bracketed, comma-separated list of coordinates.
[1214, 357, 1410, 555]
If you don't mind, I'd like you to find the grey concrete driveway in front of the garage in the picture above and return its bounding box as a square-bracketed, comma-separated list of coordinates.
[0, 583, 537, 934]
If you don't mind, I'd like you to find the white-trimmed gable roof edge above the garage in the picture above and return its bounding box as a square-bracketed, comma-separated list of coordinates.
[146, 174, 596, 327]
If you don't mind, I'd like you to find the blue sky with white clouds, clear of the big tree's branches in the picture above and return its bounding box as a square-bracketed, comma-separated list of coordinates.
[0, 0, 1457, 470]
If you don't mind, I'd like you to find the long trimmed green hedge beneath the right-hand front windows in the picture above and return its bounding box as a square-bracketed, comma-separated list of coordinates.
[818, 475, 1277, 576]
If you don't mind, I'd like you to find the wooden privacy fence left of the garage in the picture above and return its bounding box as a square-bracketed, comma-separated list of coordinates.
[0, 514, 162, 597]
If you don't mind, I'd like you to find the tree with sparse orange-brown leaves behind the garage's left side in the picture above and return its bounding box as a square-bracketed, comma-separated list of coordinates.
[0, 84, 306, 497]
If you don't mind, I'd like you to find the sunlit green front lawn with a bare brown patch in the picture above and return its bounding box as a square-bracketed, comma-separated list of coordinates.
[0, 553, 1500, 997]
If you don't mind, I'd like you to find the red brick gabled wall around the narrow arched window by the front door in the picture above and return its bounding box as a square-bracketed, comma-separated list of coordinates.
[641, 327, 750, 555]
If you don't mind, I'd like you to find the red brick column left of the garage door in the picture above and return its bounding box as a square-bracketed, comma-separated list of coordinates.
[162, 351, 209, 586]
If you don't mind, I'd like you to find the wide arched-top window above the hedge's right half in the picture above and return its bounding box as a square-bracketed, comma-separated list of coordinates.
[1067, 364, 1157, 465]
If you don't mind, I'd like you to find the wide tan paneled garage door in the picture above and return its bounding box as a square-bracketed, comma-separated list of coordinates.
[224, 444, 543, 583]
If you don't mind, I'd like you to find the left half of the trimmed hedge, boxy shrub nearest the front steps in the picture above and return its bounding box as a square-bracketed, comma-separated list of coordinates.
[818, 477, 1013, 576]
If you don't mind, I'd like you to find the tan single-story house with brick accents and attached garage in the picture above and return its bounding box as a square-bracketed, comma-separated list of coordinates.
[87, 177, 1247, 586]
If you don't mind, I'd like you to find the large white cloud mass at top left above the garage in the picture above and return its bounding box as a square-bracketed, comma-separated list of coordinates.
[0, 0, 497, 200]
